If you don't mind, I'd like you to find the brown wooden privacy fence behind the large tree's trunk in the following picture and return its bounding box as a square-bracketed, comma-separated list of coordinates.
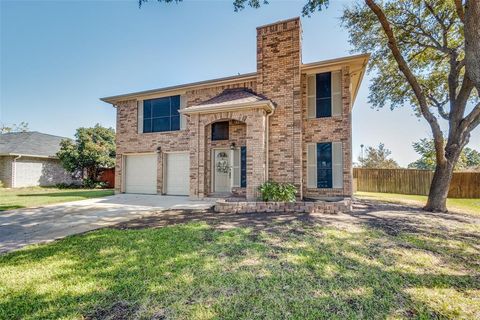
[353, 168, 480, 198]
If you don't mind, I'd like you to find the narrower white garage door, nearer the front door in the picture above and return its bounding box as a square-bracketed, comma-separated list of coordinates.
[164, 153, 190, 195]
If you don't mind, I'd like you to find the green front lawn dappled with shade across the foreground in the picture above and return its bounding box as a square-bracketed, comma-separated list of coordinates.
[0, 210, 480, 319]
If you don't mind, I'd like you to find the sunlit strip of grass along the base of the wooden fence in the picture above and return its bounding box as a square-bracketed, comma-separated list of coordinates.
[355, 191, 480, 215]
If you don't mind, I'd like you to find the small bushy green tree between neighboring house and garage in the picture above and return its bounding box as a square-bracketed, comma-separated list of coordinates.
[57, 124, 115, 185]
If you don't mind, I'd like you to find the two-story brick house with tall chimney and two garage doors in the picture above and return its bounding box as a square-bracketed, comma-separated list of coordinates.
[102, 18, 368, 199]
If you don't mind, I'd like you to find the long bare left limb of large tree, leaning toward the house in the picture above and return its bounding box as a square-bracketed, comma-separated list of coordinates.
[365, 0, 446, 164]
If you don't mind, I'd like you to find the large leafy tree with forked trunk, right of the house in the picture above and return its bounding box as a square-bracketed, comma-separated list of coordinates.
[139, 0, 480, 212]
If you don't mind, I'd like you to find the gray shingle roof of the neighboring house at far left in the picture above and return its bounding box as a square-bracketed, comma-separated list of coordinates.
[0, 131, 68, 157]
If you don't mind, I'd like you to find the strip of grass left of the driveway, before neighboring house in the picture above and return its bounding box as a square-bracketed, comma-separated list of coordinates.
[0, 187, 113, 211]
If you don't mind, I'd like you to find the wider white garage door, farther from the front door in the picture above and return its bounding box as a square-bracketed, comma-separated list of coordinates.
[125, 154, 158, 194]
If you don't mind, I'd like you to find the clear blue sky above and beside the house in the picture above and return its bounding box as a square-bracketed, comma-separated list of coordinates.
[0, 0, 480, 165]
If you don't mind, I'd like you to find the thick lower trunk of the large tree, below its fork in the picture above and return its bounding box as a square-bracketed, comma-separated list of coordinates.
[423, 161, 455, 212]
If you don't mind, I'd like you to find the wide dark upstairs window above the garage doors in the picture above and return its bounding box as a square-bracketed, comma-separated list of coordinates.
[143, 96, 180, 132]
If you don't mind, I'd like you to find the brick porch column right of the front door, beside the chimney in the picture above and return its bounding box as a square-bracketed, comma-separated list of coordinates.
[246, 109, 266, 200]
